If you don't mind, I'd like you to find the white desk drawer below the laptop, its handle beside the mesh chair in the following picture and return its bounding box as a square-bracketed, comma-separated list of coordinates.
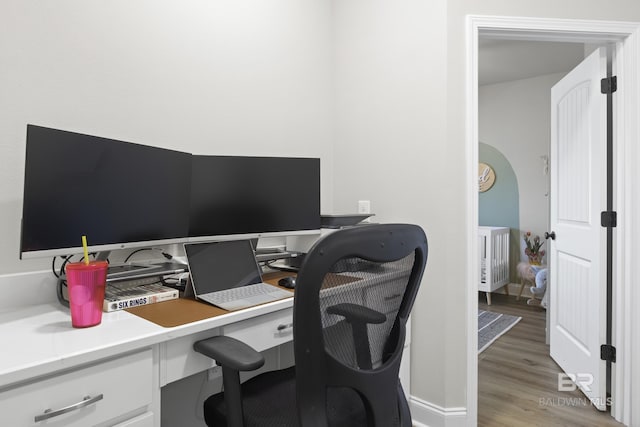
[222, 308, 293, 351]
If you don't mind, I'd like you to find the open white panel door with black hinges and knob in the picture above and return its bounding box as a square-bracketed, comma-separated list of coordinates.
[547, 49, 606, 410]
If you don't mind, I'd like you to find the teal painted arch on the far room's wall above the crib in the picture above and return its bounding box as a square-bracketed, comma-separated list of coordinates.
[478, 142, 520, 283]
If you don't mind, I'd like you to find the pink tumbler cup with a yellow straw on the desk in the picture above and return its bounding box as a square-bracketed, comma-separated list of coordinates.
[65, 261, 109, 328]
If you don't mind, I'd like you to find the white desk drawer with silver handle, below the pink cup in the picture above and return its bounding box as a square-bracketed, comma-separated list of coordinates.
[0, 350, 153, 427]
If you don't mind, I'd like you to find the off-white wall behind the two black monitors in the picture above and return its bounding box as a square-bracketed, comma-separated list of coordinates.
[0, 0, 333, 274]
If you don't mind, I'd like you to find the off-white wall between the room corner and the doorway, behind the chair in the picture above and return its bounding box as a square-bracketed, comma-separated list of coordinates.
[334, 0, 450, 406]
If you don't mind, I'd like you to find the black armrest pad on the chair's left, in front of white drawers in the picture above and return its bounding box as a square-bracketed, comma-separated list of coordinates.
[193, 335, 264, 371]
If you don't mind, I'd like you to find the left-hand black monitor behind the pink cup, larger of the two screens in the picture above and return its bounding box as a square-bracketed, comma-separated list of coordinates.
[21, 125, 192, 256]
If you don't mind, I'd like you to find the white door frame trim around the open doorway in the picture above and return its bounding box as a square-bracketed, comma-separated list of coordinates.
[467, 16, 639, 425]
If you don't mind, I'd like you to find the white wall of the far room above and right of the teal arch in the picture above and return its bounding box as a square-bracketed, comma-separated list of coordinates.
[478, 73, 564, 260]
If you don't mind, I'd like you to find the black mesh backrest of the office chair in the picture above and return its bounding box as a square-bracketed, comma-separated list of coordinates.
[293, 224, 427, 427]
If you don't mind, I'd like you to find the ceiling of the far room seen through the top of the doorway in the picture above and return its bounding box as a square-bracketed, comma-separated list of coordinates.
[478, 37, 585, 86]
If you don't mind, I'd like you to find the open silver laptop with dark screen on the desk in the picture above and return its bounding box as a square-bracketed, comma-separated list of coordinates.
[184, 240, 292, 311]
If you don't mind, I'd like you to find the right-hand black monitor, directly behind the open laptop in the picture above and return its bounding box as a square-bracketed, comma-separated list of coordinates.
[189, 155, 320, 236]
